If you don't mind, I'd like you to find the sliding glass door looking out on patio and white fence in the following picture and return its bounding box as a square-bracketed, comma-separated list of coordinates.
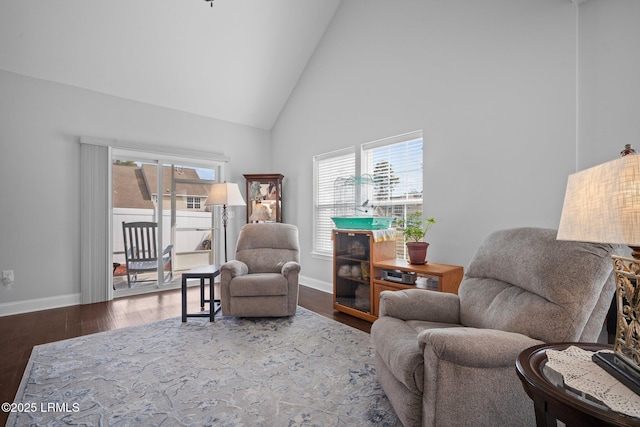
[112, 150, 221, 296]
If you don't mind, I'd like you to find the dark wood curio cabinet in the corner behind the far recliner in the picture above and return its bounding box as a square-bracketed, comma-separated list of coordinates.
[244, 173, 284, 222]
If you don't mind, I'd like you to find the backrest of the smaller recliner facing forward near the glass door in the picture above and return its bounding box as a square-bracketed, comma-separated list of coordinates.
[236, 223, 300, 273]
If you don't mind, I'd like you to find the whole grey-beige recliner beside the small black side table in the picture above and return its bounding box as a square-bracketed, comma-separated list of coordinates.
[220, 223, 300, 317]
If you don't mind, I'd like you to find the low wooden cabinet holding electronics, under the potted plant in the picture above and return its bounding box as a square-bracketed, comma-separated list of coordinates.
[372, 259, 464, 319]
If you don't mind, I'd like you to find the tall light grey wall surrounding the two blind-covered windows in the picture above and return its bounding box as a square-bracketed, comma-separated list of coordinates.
[272, 0, 576, 283]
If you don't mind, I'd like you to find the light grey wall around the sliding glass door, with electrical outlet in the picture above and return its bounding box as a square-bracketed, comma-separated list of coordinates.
[0, 71, 270, 315]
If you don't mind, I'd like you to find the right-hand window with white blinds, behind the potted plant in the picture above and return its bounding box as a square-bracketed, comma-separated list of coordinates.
[361, 131, 423, 258]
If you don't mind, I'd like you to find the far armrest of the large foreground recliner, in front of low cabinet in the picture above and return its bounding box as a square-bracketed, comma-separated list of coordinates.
[378, 289, 460, 323]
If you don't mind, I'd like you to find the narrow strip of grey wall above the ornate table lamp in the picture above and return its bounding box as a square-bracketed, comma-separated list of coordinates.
[578, 0, 640, 169]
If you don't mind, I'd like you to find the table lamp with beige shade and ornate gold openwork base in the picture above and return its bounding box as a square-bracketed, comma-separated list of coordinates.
[557, 146, 640, 394]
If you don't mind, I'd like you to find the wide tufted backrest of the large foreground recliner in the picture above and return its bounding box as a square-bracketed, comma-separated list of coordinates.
[458, 228, 615, 342]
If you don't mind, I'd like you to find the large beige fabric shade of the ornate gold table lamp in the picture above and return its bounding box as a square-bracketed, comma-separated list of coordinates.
[557, 154, 640, 246]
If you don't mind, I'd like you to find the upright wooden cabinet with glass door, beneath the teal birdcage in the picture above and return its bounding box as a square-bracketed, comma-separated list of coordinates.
[332, 230, 396, 322]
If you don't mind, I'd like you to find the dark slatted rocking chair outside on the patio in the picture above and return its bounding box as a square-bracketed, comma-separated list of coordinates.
[122, 222, 173, 288]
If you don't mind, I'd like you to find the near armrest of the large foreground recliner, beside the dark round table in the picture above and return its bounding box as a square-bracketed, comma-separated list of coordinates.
[418, 327, 543, 368]
